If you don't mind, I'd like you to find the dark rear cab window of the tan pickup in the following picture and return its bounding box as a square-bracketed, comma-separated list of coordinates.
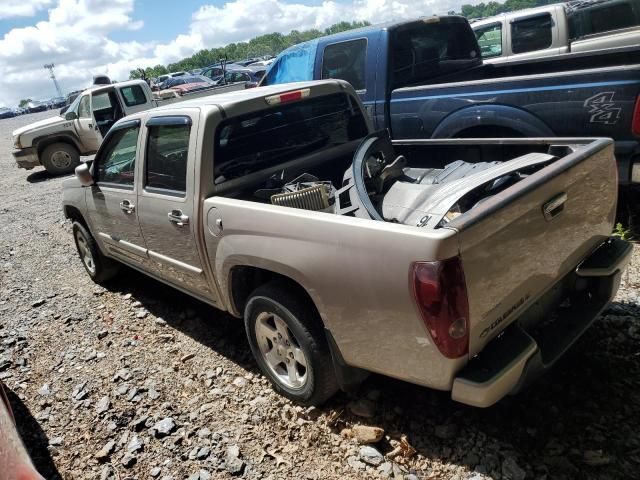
[213, 93, 367, 186]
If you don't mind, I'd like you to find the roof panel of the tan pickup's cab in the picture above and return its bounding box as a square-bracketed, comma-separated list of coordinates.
[147, 80, 348, 113]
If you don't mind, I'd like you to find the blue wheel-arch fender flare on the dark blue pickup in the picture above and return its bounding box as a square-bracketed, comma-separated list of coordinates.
[431, 105, 555, 138]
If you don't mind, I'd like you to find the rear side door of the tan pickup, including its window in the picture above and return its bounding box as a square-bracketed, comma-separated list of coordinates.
[138, 112, 216, 302]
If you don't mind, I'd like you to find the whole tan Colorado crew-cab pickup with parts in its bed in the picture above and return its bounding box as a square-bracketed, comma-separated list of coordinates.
[63, 80, 631, 407]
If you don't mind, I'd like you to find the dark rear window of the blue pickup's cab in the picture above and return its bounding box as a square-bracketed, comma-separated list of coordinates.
[389, 18, 481, 88]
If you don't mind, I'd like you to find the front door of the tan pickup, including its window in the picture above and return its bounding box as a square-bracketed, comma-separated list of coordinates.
[87, 120, 147, 267]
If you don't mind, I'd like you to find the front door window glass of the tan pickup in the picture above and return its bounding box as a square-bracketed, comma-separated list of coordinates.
[96, 126, 140, 187]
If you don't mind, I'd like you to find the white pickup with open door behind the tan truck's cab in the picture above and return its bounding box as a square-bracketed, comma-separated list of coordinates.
[13, 80, 245, 175]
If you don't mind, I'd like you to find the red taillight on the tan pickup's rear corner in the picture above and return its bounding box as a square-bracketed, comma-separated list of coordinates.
[410, 257, 469, 358]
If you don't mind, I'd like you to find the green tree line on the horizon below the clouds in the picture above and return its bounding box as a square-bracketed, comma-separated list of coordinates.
[129, 22, 370, 79]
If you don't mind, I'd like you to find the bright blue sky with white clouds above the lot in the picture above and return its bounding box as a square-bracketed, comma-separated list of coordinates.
[0, 0, 480, 107]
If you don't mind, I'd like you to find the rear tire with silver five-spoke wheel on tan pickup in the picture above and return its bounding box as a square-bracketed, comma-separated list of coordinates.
[244, 282, 338, 405]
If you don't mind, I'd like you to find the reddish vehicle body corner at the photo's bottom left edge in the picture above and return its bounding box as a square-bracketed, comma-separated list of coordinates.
[0, 382, 44, 480]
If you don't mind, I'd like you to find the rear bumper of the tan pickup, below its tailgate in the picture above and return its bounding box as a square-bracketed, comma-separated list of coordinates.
[451, 239, 632, 407]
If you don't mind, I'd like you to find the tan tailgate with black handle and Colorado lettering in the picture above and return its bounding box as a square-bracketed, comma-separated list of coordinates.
[449, 139, 618, 356]
